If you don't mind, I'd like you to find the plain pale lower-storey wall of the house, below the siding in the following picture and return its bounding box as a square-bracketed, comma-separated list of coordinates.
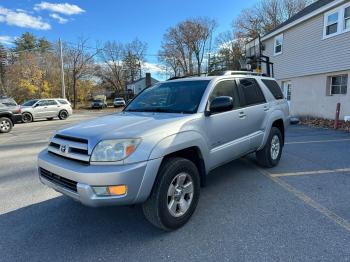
[279, 70, 350, 119]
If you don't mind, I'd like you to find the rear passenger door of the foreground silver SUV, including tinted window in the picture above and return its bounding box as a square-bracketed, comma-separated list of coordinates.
[237, 78, 270, 151]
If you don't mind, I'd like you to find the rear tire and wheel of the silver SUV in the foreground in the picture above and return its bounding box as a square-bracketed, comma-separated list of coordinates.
[256, 127, 283, 168]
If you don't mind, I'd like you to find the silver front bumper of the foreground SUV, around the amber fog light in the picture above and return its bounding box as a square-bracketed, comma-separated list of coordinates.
[38, 150, 162, 207]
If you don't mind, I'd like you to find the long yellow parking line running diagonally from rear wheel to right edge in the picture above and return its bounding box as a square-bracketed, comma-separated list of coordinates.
[245, 160, 350, 231]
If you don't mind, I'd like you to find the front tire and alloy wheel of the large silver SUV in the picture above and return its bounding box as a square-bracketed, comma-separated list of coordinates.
[142, 157, 200, 231]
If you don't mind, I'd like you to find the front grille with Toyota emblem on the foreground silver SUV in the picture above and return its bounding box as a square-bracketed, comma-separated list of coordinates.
[48, 134, 90, 163]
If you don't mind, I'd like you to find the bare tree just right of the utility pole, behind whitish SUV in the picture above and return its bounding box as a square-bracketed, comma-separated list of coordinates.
[64, 38, 98, 108]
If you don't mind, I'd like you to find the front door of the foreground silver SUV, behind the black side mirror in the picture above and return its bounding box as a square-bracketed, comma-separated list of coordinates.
[205, 80, 249, 169]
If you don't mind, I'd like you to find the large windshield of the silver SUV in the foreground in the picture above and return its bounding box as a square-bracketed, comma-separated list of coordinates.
[124, 80, 209, 114]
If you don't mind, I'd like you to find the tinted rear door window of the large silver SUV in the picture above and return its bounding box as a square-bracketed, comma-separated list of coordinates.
[239, 78, 266, 106]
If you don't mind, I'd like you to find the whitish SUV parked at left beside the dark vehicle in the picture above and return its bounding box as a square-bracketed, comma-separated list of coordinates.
[21, 98, 73, 123]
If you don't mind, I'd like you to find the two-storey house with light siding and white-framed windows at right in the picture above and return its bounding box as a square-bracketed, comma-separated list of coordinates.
[246, 0, 350, 119]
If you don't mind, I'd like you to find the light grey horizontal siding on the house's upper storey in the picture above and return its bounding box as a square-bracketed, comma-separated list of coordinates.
[263, 9, 350, 79]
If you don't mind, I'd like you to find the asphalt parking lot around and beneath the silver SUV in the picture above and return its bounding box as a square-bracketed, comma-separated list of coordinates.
[0, 112, 350, 262]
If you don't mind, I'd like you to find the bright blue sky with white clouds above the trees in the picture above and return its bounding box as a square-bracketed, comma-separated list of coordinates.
[0, 0, 256, 78]
